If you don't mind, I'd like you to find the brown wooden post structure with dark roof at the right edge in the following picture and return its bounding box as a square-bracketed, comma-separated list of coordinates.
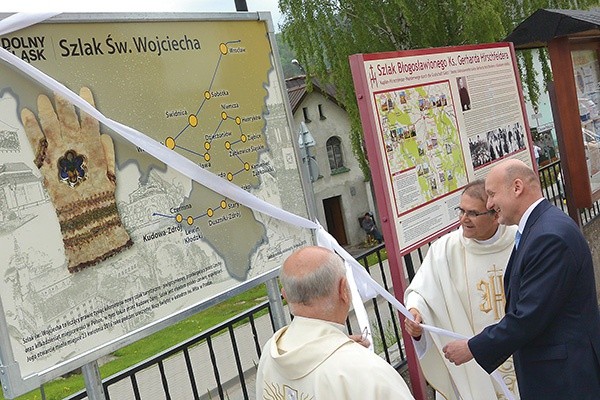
[506, 9, 600, 223]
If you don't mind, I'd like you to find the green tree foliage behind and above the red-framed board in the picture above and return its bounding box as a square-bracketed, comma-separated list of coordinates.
[279, 0, 598, 179]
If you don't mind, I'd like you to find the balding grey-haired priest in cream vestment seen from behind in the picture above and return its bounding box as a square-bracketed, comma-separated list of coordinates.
[256, 246, 413, 400]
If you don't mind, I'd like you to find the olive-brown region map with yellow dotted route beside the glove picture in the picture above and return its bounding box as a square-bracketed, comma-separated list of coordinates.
[114, 36, 275, 280]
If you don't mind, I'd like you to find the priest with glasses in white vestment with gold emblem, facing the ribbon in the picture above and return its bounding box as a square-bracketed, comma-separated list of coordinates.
[404, 180, 518, 400]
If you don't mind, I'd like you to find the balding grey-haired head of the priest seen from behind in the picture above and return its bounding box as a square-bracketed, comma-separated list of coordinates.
[279, 246, 350, 323]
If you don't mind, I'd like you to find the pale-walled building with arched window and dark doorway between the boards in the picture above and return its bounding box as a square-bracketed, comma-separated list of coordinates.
[286, 76, 375, 246]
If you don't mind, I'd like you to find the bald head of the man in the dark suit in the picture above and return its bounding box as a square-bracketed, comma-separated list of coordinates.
[485, 159, 543, 225]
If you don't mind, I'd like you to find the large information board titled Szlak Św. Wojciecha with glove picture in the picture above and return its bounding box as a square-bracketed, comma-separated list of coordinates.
[0, 13, 312, 395]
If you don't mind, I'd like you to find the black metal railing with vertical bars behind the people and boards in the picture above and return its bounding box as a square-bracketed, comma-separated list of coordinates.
[54, 161, 600, 400]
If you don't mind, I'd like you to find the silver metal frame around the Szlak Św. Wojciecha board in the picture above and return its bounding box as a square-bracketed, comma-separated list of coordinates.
[0, 12, 314, 398]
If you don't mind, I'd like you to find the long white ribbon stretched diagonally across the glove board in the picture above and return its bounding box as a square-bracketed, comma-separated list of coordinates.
[0, 13, 514, 400]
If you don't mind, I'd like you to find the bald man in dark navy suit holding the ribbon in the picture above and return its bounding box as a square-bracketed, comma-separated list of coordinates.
[444, 160, 600, 400]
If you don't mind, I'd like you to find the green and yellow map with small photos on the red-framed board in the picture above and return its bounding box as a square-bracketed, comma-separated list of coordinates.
[375, 81, 467, 213]
